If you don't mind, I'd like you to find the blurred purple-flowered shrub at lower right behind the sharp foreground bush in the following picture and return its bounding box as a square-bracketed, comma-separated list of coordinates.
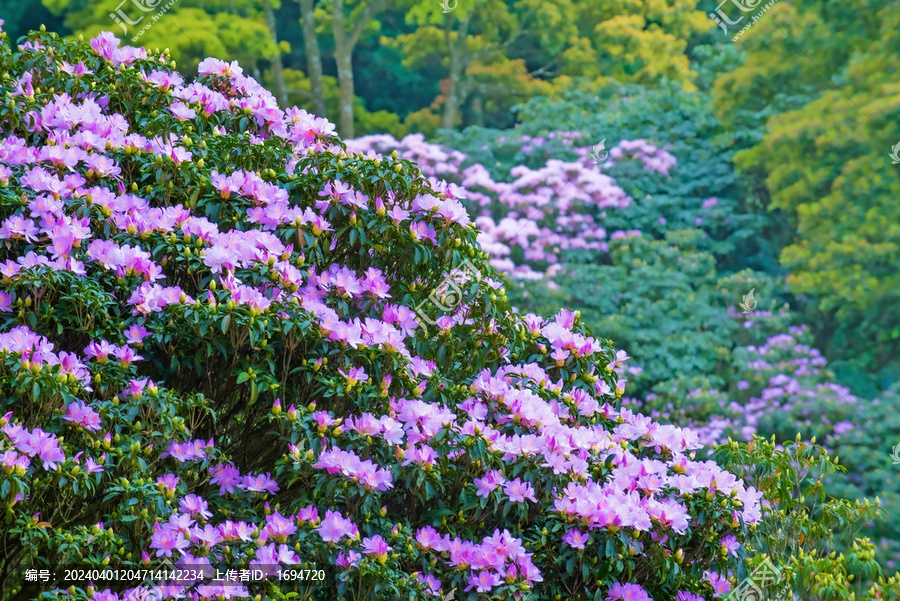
[640, 309, 900, 569]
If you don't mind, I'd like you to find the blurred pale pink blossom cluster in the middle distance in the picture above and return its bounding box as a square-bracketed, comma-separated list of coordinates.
[348, 132, 676, 286]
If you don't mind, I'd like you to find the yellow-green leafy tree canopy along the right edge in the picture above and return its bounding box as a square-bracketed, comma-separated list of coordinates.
[713, 0, 900, 388]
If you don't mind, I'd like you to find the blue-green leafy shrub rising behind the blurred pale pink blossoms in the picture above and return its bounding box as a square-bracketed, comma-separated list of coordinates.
[438, 82, 772, 271]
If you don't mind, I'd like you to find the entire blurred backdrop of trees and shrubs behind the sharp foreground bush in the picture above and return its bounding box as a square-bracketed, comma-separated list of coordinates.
[0, 0, 900, 567]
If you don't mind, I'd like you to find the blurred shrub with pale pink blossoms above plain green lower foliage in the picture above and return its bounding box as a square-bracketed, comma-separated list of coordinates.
[338, 134, 749, 394]
